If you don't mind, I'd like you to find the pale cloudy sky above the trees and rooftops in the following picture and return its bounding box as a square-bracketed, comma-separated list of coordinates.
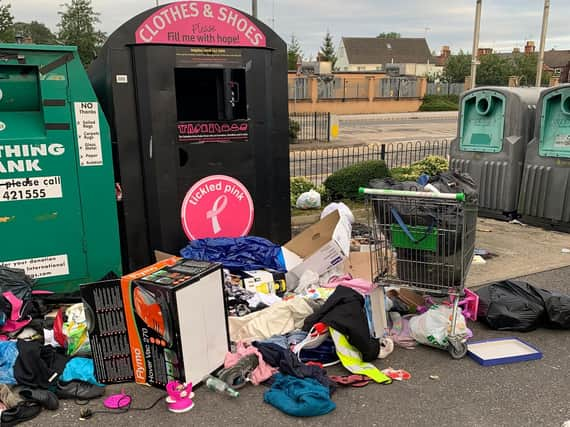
[7, 0, 570, 58]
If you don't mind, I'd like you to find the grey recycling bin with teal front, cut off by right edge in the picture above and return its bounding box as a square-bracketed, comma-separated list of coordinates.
[519, 84, 570, 228]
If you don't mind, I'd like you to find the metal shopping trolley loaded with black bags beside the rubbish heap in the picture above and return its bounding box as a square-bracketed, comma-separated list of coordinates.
[360, 188, 477, 359]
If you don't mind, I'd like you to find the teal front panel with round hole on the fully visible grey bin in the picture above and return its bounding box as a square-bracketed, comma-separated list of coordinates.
[459, 90, 506, 153]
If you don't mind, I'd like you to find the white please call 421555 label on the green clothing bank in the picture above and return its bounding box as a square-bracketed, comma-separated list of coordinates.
[0, 176, 63, 202]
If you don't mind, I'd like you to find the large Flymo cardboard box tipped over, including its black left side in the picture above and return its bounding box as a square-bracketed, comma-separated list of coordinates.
[81, 257, 229, 388]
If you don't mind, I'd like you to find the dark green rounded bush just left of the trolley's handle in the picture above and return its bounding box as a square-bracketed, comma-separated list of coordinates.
[324, 160, 389, 200]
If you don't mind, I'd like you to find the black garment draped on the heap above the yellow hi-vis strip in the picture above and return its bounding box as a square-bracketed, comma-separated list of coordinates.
[303, 286, 380, 362]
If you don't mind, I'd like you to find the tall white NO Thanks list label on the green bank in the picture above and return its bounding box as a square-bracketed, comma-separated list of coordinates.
[74, 102, 103, 166]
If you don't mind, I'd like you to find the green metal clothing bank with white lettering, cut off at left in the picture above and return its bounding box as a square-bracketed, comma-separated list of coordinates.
[0, 44, 121, 293]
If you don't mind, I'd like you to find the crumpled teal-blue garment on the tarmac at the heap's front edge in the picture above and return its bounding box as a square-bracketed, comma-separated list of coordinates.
[263, 374, 336, 417]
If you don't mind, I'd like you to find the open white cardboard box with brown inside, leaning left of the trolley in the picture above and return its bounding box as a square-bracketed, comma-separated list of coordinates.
[282, 211, 351, 278]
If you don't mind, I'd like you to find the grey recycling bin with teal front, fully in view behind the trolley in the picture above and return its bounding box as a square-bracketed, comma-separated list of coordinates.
[450, 87, 541, 216]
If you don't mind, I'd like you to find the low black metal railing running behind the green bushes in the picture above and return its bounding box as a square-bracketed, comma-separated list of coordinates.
[289, 139, 450, 185]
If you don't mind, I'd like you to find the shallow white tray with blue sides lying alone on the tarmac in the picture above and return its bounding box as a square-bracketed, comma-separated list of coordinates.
[467, 337, 542, 366]
